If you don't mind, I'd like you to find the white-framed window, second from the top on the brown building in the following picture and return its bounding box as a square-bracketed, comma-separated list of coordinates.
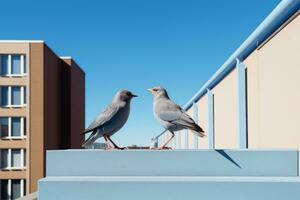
[0, 86, 26, 107]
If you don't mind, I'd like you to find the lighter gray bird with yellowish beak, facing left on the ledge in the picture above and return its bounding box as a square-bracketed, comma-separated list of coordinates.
[148, 87, 205, 149]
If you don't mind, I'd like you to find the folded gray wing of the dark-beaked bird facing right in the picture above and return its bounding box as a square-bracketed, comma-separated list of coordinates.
[82, 103, 120, 134]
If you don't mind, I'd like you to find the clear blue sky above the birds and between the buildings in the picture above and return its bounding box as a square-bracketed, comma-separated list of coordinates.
[0, 0, 279, 145]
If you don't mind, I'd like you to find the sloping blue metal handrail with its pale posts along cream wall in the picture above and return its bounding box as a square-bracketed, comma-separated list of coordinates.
[152, 0, 300, 148]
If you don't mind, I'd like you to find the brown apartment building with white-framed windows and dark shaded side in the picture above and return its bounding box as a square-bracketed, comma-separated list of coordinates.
[0, 41, 85, 199]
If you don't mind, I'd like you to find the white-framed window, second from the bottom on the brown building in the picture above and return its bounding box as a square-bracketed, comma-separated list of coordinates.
[0, 149, 26, 170]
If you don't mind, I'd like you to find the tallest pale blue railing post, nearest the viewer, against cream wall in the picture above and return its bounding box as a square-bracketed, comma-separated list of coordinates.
[236, 59, 247, 149]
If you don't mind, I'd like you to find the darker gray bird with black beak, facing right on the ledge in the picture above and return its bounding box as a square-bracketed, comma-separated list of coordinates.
[81, 90, 137, 149]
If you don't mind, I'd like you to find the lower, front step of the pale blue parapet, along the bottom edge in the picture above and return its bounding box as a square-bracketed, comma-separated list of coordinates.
[38, 177, 300, 200]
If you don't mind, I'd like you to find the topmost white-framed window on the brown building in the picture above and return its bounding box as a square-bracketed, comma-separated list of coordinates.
[0, 54, 26, 76]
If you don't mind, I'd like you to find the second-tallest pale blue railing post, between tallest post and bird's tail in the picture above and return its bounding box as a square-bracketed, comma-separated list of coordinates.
[207, 89, 215, 149]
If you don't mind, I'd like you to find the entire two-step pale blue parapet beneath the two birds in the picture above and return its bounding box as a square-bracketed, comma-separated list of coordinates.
[38, 150, 300, 200]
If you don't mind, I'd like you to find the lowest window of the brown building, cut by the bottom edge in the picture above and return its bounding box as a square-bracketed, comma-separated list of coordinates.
[0, 179, 26, 200]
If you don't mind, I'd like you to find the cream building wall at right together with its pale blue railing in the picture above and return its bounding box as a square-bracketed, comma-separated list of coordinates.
[157, 1, 300, 149]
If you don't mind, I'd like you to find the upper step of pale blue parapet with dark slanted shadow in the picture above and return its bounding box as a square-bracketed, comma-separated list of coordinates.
[46, 150, 298, 177]
